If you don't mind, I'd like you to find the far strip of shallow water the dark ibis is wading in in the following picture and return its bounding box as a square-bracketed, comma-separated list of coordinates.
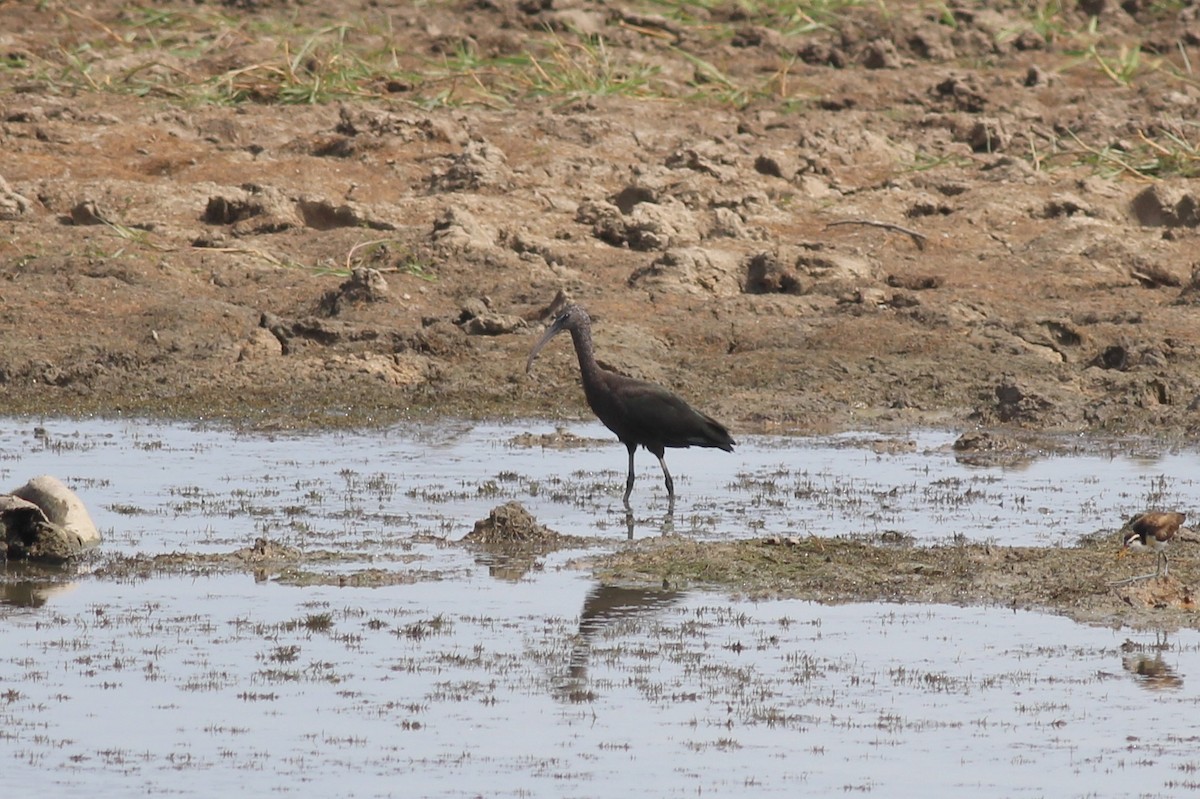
[0, 421, 1200, 547]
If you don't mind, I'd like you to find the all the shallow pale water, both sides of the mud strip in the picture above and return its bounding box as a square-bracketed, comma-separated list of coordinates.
[0, 421, 1200, 797]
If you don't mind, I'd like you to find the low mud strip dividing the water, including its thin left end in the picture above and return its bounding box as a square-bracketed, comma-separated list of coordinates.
[35, 523, 1200, 630]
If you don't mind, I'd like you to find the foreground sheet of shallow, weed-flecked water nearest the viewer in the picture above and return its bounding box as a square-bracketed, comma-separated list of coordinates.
[7, 572, 1200, 797]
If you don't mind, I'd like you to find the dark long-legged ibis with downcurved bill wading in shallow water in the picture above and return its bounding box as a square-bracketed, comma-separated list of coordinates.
[526, 305, 737, 507]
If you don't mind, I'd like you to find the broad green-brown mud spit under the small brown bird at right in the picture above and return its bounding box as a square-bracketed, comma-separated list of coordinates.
[589, 527, 1200, 629]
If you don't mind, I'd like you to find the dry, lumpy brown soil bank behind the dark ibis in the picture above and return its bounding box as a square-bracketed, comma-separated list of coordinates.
[0, 0, 1200, 614]
